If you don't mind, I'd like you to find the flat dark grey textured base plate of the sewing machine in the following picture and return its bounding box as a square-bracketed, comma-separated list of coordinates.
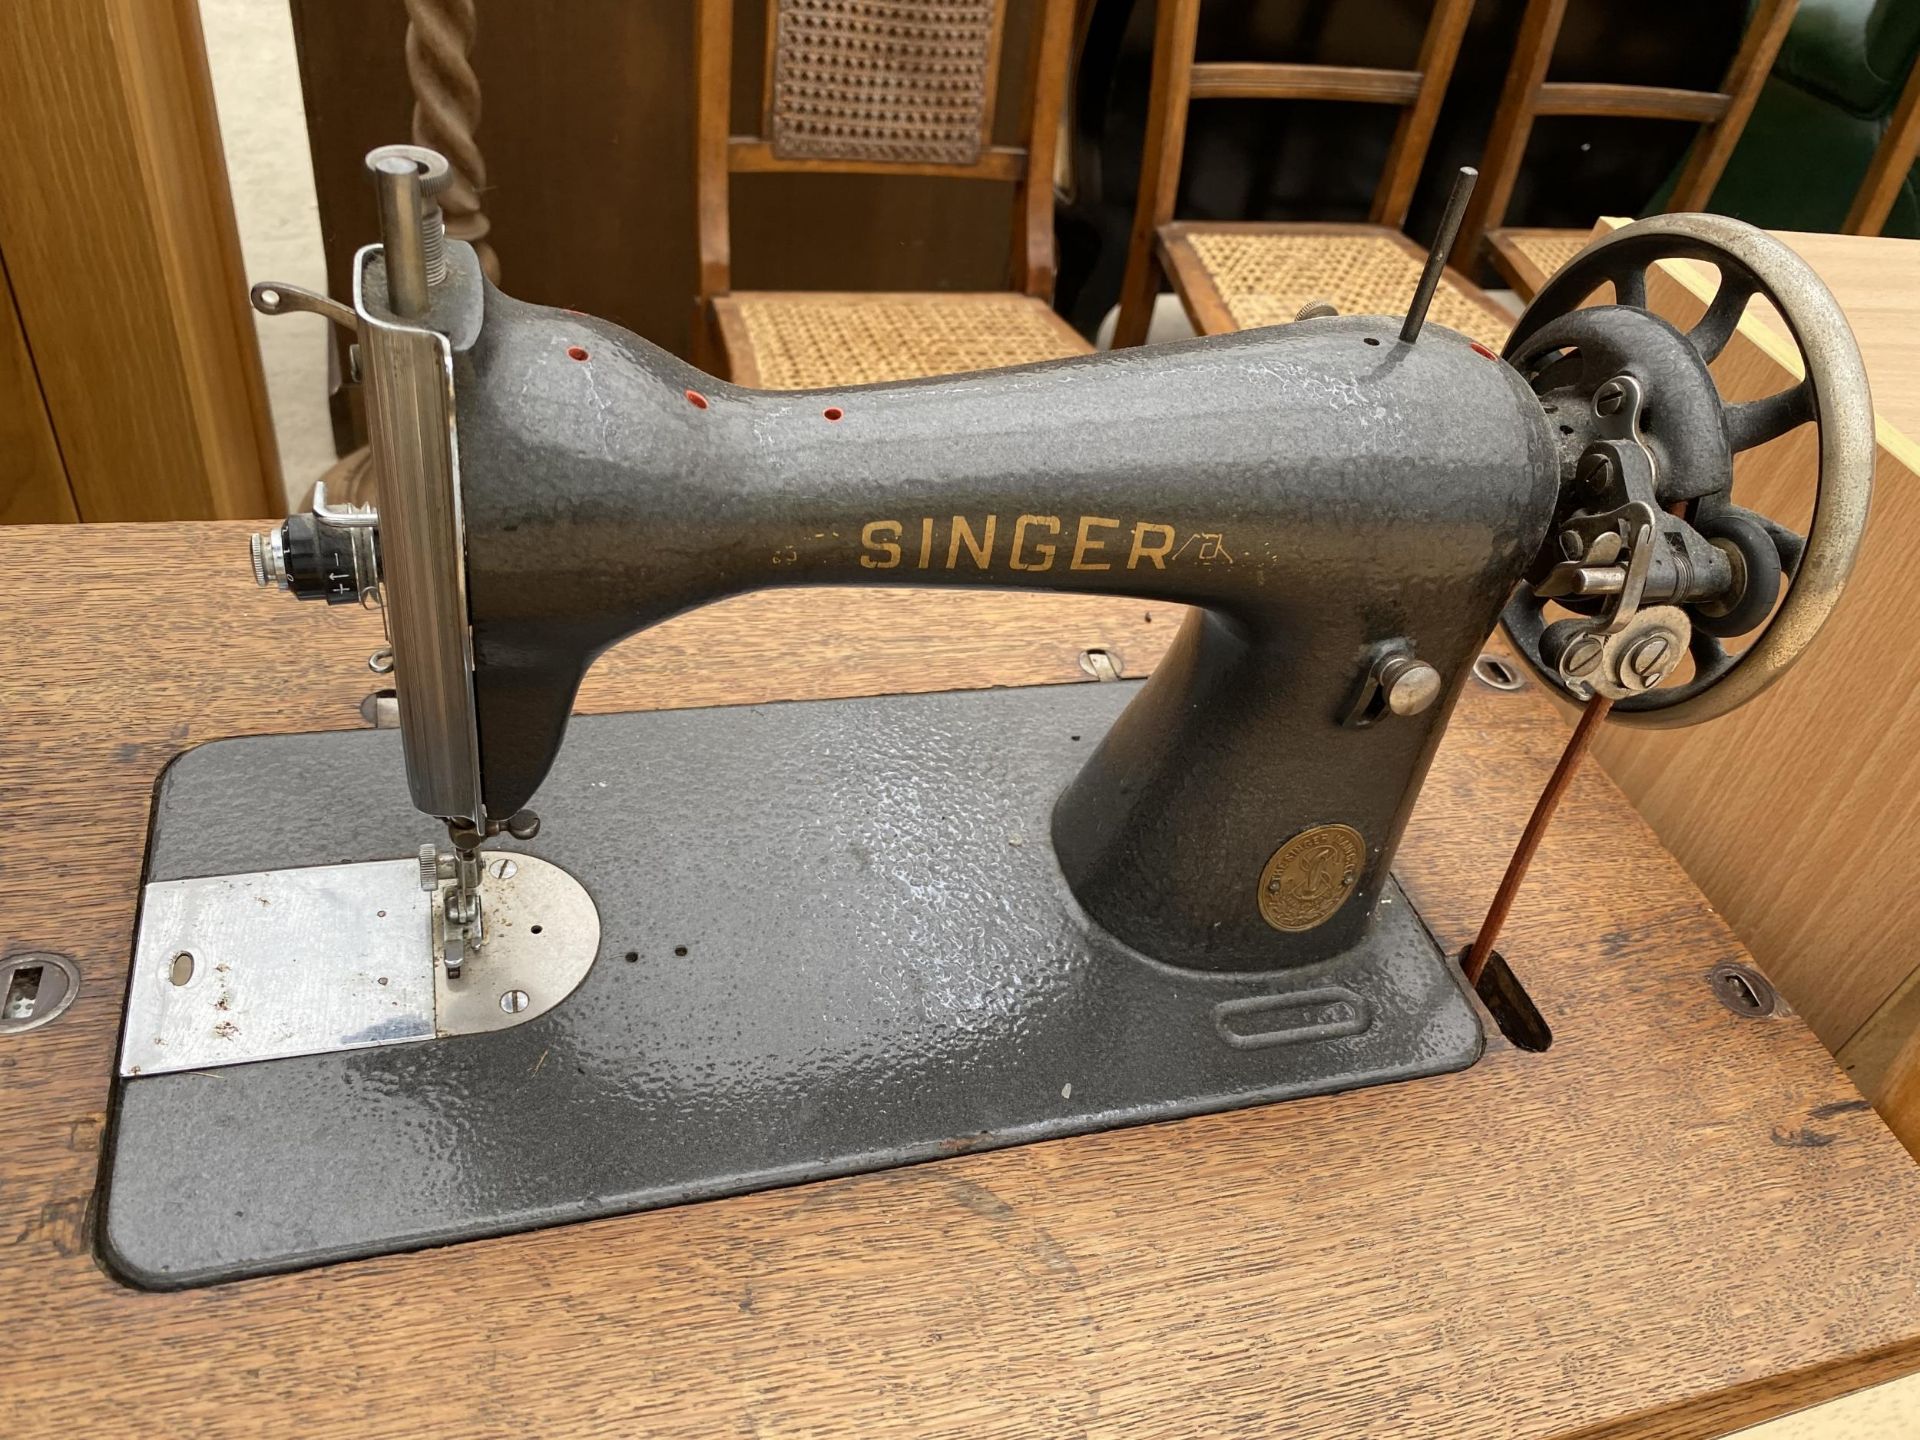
[100, 684, 1482, 1288]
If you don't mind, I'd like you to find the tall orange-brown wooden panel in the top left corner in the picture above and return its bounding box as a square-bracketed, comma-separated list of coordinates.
[0, 0, 280, 520]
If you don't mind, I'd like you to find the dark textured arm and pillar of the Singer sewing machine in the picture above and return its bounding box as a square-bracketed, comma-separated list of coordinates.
[455, 290, 1559, 970]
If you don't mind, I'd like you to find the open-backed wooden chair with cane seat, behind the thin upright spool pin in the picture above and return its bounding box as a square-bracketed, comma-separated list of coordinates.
[1114, 0, 1513, 348]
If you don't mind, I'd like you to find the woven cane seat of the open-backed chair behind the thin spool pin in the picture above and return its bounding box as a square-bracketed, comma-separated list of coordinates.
[1160, 223, 1513, 349]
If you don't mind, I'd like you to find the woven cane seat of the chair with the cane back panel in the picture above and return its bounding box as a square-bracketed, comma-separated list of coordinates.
[712, 292, 1092, 390]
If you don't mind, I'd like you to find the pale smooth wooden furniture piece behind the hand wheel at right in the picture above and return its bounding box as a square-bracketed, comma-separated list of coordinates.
[1596, 231, 1920, 1059]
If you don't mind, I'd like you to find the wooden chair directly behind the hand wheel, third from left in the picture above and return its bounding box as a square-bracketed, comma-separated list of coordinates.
[1453, 0, 1799, 300]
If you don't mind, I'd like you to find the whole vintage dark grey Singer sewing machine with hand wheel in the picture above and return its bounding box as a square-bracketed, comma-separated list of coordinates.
[102, 150, 1872, 1286]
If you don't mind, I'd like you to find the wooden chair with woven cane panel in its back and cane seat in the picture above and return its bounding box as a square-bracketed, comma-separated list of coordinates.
[695, 0, 1091, 390]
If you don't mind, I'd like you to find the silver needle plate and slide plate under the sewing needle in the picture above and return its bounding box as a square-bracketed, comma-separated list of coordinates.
[119, 852, 599, 1075]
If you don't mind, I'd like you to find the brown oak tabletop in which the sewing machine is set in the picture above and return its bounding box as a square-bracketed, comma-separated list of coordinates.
[0, 524, 1920, 1440]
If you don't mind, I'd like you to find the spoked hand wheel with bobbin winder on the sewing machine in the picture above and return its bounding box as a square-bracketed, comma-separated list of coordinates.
[1503, 215, 1874, 728]
